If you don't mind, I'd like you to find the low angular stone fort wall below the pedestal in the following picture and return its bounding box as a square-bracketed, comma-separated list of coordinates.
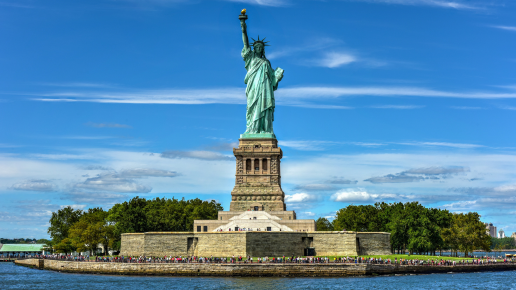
[120, 232, 391, 257]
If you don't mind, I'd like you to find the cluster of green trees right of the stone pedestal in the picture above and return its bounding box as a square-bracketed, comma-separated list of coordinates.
[333, 202, 490, 255]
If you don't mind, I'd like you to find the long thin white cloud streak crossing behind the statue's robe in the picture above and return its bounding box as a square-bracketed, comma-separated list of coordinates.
[28, 86, 516, 108]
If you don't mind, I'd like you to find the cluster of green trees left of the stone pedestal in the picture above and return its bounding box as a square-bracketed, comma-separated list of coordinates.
[47, 196, 223, 253]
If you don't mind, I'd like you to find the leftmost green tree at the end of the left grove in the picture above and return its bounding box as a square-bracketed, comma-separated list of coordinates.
[47, 206, 83, 244]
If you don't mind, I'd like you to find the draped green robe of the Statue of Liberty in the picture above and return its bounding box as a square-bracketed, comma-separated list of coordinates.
[242, 47, 283, 133]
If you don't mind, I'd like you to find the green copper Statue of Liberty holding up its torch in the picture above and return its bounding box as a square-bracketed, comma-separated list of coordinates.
[239, 9, 283, 138]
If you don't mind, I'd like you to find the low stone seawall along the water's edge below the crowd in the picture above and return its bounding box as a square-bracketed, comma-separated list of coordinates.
[15, 259, 516, 277]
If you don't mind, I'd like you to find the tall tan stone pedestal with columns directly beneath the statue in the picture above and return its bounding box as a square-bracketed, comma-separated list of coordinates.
[230, 138, 286, 211]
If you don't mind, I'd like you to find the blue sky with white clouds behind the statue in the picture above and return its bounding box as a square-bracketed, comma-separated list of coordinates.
[0, 0, 516, 238]
